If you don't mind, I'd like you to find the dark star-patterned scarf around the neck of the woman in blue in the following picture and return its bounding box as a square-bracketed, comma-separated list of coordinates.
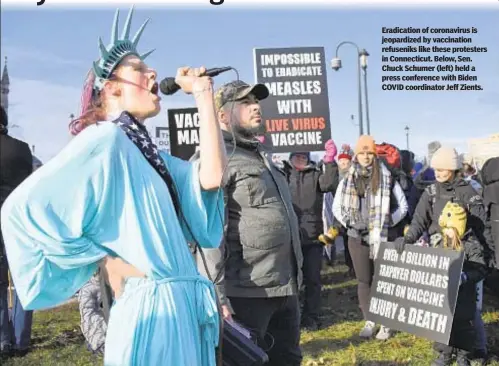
[112, 111, 180, 214]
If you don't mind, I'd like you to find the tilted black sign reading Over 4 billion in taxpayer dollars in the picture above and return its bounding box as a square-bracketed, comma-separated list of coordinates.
[367, 243, 464, 344]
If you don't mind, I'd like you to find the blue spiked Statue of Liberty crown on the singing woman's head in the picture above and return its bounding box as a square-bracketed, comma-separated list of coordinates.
[93, 6, 154, 91]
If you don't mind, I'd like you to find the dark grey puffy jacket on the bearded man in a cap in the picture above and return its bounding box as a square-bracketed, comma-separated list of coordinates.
[191, 131, 303, 312]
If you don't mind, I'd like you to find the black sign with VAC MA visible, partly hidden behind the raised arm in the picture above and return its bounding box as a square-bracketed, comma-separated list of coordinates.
[168, 108, 199, 160]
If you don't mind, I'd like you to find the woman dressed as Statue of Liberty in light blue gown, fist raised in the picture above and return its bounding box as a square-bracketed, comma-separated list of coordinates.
[1, 9, 226, 366]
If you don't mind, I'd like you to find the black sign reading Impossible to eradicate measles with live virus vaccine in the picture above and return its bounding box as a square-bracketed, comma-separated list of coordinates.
[254, 47, 331, 153]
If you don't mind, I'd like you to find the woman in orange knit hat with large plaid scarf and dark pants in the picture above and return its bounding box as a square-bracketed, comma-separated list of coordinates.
[333, 136, 407, 340]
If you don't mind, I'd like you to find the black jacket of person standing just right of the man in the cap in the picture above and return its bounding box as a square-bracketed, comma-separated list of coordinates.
[284, 161, 339, 246]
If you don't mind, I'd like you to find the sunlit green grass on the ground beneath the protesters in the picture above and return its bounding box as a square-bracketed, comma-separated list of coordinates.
[1, 265, 499, 366]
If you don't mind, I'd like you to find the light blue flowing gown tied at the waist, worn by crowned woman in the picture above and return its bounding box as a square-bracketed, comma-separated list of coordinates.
[1, 122, 223, 366]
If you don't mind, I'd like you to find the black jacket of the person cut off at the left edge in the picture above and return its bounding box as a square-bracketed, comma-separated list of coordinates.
[0, 134, 33, 285]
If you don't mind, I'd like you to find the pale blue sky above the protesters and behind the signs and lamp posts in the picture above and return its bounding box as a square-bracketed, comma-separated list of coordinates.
[0, 5, 499, 161]
